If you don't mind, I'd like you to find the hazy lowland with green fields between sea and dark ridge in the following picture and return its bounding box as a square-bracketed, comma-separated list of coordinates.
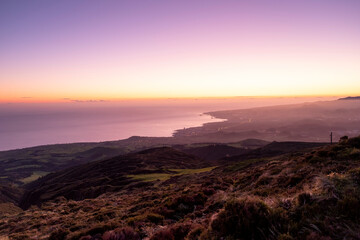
[0, 137, 268, 188]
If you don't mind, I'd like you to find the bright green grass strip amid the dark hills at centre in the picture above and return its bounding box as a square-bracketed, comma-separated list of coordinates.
[126, 167, 216, 182]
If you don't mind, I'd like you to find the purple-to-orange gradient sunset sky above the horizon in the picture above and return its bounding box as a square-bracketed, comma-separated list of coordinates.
[0, 0, 360, 102]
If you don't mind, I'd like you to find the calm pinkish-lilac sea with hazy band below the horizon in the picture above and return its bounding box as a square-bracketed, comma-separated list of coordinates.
[0, 97, 333, 150]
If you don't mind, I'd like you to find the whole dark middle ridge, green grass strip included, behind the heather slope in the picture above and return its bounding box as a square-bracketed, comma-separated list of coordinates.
[20, 142, 324, 208]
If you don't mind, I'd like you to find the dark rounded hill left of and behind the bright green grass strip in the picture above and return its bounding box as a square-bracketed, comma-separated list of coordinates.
[20, 147, 207, 208]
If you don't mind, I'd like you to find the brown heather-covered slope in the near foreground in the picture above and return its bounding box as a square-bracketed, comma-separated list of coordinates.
[0, 137, 360, 240]
